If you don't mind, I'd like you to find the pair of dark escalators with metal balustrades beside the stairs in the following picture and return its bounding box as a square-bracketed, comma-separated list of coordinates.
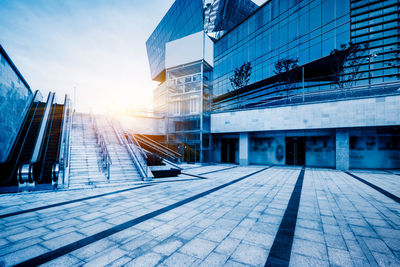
[0, 93, 70, 193]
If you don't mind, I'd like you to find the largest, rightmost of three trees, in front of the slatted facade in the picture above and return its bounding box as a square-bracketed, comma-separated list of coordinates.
[330, 43, 368, 89]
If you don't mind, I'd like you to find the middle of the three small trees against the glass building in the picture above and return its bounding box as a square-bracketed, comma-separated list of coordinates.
[274, 58, 299, 97]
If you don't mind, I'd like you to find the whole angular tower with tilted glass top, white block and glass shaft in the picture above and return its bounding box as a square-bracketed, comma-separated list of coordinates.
[146, 0, 257, 162]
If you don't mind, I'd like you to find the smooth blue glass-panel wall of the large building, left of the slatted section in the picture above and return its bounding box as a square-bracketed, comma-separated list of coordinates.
[213, 0, 350, 96]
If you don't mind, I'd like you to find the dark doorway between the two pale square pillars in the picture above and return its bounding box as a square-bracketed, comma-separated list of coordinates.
[286, 137, 306, 166]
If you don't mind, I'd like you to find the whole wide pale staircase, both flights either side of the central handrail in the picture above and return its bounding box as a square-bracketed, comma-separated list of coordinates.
[69, 113, 141, 189]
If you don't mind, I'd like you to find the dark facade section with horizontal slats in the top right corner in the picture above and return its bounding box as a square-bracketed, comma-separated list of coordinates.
[351, 0, 400, 85]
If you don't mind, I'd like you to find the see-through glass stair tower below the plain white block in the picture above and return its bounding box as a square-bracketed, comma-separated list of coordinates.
[162, 60, 212, 162]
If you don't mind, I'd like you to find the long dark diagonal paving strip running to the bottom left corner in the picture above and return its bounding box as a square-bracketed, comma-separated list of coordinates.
[15, 167, 270, 266]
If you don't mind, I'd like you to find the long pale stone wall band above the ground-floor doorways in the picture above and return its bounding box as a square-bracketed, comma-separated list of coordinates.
[211, 95, 400, 133]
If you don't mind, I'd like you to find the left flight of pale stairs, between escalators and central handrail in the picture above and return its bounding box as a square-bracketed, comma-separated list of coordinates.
[69, 113, 108, 189]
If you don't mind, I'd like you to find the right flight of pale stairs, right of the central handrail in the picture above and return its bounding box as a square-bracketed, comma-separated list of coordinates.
[98, 117, 141, 182]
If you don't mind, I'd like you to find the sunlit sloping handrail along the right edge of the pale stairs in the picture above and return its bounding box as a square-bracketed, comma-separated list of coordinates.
[111, 120, 153, 180]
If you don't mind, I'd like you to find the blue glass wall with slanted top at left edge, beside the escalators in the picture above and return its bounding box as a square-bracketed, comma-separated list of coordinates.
[0, 46, 33, 162]
